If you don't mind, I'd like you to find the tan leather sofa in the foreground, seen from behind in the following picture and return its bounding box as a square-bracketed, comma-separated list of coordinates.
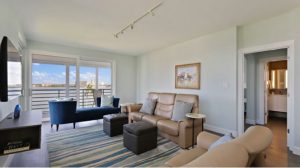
[166, 126, 272, 167]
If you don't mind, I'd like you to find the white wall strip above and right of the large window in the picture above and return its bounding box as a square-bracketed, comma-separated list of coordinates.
[28, 41, 136, 102]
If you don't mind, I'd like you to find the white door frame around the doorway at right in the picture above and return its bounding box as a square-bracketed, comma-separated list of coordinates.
[237, 40, 295, 149]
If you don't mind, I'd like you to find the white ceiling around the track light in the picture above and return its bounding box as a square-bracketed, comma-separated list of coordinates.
[6, 0, 300, 55]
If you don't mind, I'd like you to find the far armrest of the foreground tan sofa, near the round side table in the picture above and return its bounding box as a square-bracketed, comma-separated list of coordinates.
[197, 131, 220, 150]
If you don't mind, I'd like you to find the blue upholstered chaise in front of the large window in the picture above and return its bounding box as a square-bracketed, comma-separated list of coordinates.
[49, 97, 121, 131]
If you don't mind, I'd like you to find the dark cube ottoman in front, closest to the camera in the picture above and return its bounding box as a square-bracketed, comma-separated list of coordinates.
[123, 121, 157, 154]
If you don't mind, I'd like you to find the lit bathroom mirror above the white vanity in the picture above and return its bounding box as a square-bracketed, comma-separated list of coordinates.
[271, 69, 287, 89]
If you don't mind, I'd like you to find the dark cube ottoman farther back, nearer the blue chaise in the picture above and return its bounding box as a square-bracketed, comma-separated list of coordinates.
[103, 113, 128, 137]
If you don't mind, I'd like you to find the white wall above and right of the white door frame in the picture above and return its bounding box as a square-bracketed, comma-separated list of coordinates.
[238, 5, 300, 151]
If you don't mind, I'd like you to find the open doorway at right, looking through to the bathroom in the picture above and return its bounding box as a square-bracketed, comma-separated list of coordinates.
[245, 49, 288, 166]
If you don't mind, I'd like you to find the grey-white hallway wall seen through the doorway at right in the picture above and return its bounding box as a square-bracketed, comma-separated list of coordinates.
[246, 49, 287, 124]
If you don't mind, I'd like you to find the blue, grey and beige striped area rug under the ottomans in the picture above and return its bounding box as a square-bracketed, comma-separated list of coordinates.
[47, 125, 181, 167]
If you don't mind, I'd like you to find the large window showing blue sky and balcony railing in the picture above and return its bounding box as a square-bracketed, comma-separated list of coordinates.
[31, 55, 112, 118]
